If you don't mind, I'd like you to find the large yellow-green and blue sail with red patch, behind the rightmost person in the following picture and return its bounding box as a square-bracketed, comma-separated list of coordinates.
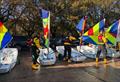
[82, 19, 105, 45]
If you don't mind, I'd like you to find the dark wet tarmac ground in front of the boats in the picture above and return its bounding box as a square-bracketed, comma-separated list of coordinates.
[0, 52, 120, 82]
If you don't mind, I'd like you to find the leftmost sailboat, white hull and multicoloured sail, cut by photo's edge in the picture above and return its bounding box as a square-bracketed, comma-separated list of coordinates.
[0, 22, 18, 73]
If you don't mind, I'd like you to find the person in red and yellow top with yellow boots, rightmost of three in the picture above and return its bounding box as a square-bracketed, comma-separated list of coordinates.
[96, 31, 108, 65]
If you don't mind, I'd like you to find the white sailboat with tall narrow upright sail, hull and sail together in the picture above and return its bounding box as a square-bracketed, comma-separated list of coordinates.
[38, 9, 56, 65]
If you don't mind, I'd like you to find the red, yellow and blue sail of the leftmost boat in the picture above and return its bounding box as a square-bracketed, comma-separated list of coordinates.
[0, 22, 12, 49]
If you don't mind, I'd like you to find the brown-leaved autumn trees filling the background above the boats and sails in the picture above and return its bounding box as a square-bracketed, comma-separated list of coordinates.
[0, 0, 120, 36]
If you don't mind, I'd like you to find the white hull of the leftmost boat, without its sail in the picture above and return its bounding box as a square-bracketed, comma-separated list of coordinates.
[0, 48, 18, 73]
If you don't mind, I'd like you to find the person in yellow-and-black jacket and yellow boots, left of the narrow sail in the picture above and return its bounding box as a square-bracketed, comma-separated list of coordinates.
[32, 36, 41, 69]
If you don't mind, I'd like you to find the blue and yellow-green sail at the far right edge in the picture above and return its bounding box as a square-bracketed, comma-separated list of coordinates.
[105, 20, 120, 45]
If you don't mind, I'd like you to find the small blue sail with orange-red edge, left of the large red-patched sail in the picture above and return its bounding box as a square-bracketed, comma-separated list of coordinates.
[76, 16, 86, 32]
